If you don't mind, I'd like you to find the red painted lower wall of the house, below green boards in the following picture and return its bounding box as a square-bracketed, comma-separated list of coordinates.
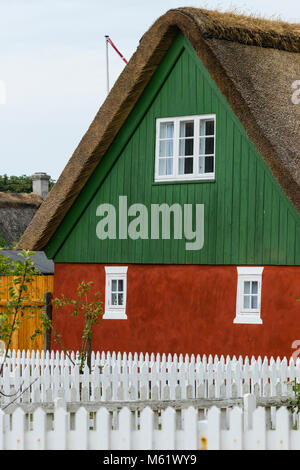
[54, 263, 300, 357]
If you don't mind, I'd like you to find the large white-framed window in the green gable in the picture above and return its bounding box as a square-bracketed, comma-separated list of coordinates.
[154, 114, 216, 182]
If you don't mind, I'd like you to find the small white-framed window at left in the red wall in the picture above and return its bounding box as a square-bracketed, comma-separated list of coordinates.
[103, 266, 128, 320]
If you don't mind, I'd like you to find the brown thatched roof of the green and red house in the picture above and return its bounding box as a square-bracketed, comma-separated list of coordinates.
[19, 8, 300, 250]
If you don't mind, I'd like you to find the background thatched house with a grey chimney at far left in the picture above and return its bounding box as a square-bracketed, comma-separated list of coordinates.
[0, 173, 50, 247]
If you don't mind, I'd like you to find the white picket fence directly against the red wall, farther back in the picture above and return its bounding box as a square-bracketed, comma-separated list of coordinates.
[0, 351, 300, 403]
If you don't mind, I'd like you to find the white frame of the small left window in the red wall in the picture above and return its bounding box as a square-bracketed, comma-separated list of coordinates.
[102, 266, 128, 320]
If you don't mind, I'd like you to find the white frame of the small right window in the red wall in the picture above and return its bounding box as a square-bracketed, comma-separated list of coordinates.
[233, 266, 264, 325]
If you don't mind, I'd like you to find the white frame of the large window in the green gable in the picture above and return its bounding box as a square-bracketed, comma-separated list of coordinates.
[154, 114, 216, 182]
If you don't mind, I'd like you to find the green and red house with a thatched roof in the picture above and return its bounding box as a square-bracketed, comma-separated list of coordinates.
[19, 8, 300, 356]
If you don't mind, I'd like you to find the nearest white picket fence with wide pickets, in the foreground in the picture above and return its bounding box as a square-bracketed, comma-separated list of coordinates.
[0, 395, 300, 450]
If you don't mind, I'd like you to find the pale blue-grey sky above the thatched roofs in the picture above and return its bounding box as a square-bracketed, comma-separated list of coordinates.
[0, 0, 300, 179]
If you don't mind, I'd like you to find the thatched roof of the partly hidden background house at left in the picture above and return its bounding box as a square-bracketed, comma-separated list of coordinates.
[0, 192, 43, 245]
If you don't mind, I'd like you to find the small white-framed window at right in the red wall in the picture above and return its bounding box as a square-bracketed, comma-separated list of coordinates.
[234, 266, 264, 324]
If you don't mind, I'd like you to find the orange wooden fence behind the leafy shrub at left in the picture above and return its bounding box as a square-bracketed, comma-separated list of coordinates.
[0, 276, 54, 350]
